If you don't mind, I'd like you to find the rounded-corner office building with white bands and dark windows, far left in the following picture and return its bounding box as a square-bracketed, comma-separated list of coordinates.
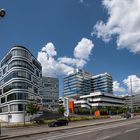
[0, 46, 42, 122]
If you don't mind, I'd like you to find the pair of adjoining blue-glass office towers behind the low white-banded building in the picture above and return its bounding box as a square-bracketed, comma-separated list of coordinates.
[64, 70, 113, 98]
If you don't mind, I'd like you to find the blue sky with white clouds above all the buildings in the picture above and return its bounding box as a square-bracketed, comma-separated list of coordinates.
[0, 0, 140, 94]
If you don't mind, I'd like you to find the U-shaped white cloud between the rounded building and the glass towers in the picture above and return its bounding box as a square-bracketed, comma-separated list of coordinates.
[37, 38, 94, 77]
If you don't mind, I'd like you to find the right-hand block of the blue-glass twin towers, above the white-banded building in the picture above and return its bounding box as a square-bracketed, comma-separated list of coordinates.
[91, 73, 113, 93]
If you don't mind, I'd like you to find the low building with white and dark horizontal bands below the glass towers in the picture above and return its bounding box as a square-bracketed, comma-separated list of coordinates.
[74, 92, 125, 109]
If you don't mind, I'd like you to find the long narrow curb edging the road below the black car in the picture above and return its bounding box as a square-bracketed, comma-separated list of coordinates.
[0, 118, 126, 140]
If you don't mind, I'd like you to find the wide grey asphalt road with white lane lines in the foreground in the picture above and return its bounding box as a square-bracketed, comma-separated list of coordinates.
[6, 119, 140, 140]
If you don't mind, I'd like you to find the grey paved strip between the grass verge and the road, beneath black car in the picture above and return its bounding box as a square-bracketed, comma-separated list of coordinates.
[0, 117, 140, 140]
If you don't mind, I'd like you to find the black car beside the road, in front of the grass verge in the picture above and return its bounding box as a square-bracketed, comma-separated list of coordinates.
[48, 119, 69, 127]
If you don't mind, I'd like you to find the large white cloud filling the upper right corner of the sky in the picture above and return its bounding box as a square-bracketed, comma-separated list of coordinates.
[91, 0, 140, 53]
